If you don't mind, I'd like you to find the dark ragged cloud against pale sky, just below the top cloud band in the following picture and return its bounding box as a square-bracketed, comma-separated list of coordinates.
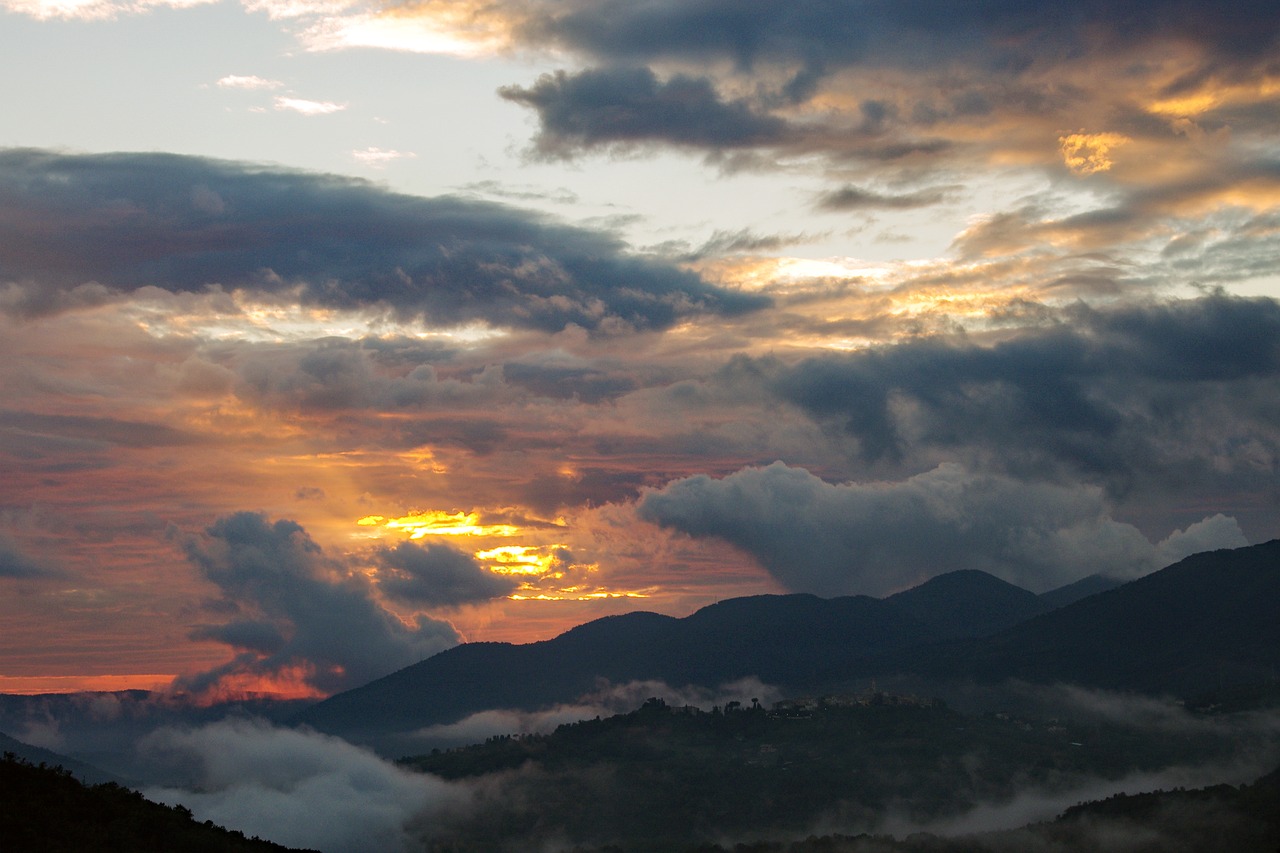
[499, 68, 787, 156]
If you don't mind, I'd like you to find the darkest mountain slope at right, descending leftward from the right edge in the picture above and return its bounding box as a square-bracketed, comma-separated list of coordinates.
[861, 539, 1280, 695]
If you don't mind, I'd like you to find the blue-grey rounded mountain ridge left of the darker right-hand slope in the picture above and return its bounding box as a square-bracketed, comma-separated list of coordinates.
[294, 571, 1046, 740]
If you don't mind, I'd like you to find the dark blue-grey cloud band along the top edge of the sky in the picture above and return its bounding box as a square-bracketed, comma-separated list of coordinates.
[525, 0, 1280, 72]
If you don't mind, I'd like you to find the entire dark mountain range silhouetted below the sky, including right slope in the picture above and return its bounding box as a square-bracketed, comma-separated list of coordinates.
[294, 540, 1280, 742]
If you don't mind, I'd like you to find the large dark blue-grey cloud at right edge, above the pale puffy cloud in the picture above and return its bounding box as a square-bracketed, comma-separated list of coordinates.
[747, 296, 1280, 491]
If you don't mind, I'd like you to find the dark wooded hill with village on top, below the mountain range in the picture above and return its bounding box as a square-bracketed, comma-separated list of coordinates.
[401, 693, 1277, 853]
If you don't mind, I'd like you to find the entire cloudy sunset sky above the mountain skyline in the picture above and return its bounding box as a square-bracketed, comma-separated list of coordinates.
[0, 0, 1280, 697]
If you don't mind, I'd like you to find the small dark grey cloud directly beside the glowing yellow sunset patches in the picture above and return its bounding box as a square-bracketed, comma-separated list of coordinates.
[378, 542, 518, 607]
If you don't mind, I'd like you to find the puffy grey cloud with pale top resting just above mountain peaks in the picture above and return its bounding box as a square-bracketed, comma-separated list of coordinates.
[639, 462, 1239, 596]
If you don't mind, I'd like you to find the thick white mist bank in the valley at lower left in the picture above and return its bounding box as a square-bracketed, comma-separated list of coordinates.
[140, 720, 468, 853]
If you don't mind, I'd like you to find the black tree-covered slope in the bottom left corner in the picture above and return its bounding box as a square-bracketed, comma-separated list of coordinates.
[0, 753, 314, 853]
